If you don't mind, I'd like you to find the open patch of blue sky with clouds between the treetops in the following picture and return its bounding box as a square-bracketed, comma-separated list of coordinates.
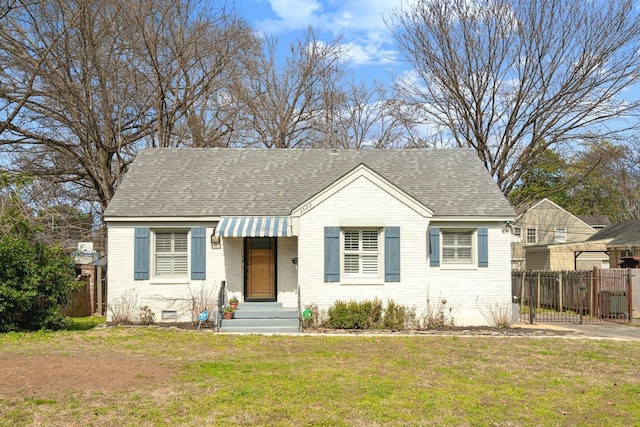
[236, 0, 407, 86]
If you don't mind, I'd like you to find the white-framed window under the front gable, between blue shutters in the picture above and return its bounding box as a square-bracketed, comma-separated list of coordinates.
[343, 229, 380, 277]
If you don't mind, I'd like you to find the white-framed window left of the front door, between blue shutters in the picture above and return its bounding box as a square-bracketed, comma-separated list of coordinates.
[155, 231, 189, 277]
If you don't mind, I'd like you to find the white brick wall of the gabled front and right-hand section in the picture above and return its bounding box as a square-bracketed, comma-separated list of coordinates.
[298, 177, 511, 325]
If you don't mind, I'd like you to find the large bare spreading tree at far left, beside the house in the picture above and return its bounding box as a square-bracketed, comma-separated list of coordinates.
[0, 0, 255, 214]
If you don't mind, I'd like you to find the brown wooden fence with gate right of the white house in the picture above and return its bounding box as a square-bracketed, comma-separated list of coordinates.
[511, 268, 640, 323]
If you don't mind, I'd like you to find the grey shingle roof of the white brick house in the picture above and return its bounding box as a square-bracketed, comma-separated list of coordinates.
[105, 148, 514, 220]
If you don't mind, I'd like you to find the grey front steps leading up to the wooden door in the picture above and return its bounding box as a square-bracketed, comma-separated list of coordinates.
[220, 302, 300, 334]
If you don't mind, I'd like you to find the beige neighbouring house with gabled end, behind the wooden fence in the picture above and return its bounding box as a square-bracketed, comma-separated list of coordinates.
[511, 199, 609, 271]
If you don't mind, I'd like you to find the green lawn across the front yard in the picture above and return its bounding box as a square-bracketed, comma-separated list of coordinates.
[0, 328, 640, 426]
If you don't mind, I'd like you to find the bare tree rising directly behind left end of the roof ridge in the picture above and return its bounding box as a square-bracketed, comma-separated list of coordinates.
[128, 0, 259, 147]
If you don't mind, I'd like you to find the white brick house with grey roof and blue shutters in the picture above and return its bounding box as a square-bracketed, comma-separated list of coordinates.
[105, 149, 514, 325]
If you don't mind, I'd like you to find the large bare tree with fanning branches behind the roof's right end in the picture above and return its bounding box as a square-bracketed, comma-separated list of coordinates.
[391, 0, 640, 194]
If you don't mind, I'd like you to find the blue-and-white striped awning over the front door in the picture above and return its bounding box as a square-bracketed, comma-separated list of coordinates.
[215, 216, 289, 237]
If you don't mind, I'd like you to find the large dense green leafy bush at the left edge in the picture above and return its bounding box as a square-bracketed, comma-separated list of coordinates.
[0, 196, 82, 332]
